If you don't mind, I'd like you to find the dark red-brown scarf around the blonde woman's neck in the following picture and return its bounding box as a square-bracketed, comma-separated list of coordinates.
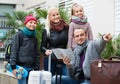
[50, 20, 68, 31]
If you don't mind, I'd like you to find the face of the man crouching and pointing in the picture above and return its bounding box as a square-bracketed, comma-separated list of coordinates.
[74, 29, 87, 44]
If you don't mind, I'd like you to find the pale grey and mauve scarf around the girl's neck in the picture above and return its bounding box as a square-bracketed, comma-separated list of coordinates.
[71, 16, 87, 24]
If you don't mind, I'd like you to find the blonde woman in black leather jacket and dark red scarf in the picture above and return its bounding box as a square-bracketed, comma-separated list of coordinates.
[41, 7, 68, 75]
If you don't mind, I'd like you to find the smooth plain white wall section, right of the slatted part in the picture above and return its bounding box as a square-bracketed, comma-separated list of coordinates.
[91, 0, 115, 37]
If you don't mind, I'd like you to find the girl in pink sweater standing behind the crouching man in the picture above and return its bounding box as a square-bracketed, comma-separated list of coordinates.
[68, 3, 93, 49]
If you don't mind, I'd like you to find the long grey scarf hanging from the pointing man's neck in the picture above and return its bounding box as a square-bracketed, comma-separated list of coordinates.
[74, 40, 89, 67]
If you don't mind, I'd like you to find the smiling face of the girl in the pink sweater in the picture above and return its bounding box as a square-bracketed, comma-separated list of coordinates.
[73, 6, 84, 17]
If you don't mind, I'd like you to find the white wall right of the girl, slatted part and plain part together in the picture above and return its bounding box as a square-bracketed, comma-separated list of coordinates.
[74, 0, 115, 38]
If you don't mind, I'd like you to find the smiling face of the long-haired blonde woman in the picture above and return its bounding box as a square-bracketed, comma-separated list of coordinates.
[48, 9, 60, 23]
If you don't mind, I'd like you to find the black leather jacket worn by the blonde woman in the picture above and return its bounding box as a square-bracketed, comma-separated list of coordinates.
[41, 28, 68, 53]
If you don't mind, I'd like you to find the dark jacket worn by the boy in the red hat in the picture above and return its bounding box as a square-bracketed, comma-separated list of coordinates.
[10, 31, 40, 69]
